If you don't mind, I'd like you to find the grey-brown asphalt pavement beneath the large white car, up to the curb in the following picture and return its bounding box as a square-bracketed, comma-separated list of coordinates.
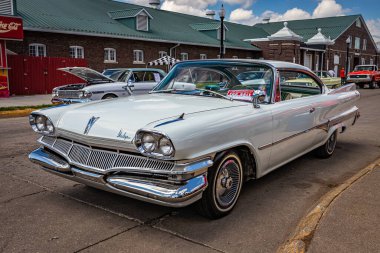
[0, 89, 380, 252]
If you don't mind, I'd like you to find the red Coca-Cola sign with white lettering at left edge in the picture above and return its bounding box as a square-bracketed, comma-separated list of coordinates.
[0, 16, 24, 40]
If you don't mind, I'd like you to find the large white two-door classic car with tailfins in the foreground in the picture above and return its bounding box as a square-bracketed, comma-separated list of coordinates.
[29, 60, 360, 218]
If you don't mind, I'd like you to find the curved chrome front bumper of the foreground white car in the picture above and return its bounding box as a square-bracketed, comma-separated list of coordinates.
[29, 148, 212, 207]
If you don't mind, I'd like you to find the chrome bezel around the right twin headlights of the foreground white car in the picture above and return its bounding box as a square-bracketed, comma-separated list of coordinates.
[135, 130, 175, 160]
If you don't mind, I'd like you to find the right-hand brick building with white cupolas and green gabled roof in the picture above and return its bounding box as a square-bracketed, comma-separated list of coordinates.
[248, 15, 379, 73]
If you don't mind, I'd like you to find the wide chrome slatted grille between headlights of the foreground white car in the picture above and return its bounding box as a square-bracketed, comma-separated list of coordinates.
[39, 136, 175, 172]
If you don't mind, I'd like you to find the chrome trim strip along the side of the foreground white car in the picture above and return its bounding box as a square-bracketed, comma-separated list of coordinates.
[258, 108, 360, 150]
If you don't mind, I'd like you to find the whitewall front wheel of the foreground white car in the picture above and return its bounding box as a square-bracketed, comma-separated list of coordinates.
[198, 151, 243, 219]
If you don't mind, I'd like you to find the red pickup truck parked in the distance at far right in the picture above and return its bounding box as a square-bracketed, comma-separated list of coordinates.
[346, 65, 380, 89]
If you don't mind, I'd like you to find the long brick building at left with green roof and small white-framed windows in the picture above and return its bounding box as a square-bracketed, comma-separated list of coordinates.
[9, 0, 261, 71]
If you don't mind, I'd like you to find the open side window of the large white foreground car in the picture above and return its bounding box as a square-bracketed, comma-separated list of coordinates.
[280, 71, 321, 101]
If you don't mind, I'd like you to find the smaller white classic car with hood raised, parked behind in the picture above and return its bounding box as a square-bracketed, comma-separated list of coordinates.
[52, 67, 166, 103]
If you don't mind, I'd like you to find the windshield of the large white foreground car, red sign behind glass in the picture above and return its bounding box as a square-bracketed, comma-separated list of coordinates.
[153, 61, 273, 103]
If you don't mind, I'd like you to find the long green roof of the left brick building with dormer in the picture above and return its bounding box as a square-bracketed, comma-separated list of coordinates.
[17, 0, 262, 50]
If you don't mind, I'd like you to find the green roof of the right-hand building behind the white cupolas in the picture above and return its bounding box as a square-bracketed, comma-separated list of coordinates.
[254, 15, 361, 41]
